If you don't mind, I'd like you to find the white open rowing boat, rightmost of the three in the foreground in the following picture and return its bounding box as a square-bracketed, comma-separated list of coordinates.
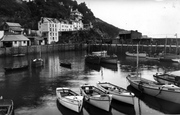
[97, 82, 134, 105]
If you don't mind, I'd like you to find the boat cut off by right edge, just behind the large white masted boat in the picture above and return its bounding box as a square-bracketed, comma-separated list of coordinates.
[153, 71, 180, 86]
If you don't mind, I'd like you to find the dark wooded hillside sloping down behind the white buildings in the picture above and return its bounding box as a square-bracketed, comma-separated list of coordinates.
[0, 0, 122, 41]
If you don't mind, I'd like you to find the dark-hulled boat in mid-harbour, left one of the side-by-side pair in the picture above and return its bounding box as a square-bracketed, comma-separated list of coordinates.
[85, 54, 101, 64]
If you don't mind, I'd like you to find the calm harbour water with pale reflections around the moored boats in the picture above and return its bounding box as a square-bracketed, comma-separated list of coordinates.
[0, 51, 180, 115]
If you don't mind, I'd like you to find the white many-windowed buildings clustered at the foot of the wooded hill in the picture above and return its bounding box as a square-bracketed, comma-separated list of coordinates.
[38, 10, 84, 44]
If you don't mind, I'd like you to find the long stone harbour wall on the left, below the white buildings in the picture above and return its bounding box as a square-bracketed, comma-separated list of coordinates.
[0, 44, 87, 56]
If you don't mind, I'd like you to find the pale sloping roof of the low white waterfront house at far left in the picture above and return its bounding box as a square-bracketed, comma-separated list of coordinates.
[2, 35, 29, 42]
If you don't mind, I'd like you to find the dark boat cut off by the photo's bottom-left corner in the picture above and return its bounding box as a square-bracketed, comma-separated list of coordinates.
[0, 96, 14, 115]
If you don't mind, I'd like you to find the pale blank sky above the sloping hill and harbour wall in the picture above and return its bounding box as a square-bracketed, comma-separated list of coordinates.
[76, 0, 180, 38]
